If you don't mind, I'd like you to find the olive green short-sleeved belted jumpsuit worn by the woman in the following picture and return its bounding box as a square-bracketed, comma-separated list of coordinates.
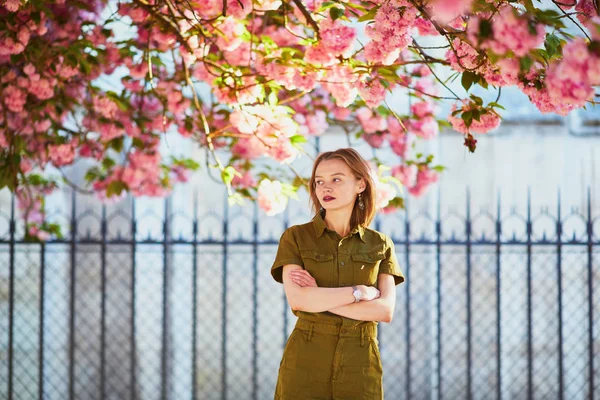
[271, 213, 404, 400]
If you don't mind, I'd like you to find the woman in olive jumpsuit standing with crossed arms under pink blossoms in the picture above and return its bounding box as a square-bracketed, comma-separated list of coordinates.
[271, 149, 404, 400]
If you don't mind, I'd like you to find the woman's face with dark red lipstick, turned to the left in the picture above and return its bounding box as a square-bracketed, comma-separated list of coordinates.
[315, 159, 365, 210]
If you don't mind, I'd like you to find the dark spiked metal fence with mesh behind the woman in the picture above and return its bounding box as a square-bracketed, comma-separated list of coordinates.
[0, 188, 600, 400]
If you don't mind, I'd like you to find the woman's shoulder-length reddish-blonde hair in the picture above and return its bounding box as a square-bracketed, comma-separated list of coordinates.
[308, 148, 375, 229]
